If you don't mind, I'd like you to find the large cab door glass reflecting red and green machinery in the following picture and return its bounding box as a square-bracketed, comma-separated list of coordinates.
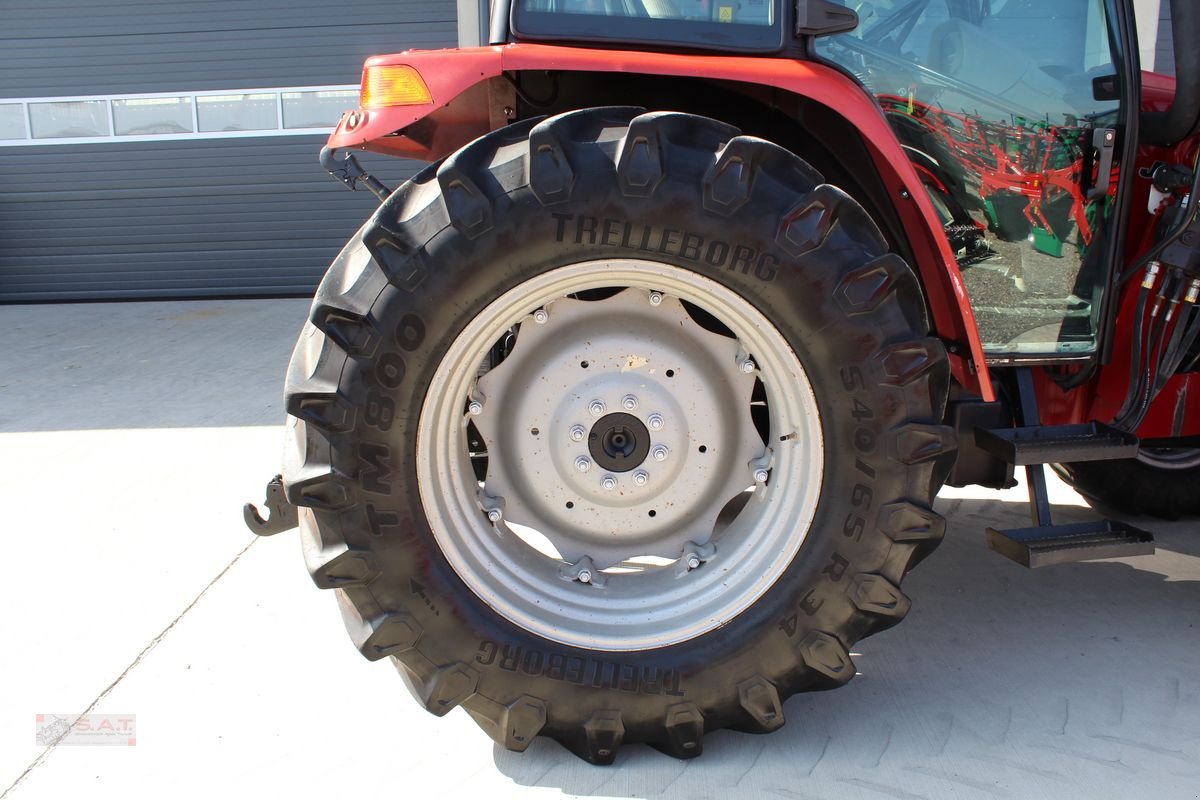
[817, 0, 1121, 354]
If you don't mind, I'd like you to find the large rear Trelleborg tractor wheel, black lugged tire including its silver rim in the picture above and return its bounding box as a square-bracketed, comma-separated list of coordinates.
[286, 108, 955, 764]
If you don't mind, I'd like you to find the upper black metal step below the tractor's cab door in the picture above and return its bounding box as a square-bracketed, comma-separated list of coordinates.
[976, 422, 1138, 467]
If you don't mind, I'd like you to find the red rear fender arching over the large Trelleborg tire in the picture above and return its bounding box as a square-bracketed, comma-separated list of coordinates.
[329, 44, 995, 401]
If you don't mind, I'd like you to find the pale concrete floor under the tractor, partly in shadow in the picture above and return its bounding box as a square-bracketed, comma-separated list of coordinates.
[0, 300, 1200, 800]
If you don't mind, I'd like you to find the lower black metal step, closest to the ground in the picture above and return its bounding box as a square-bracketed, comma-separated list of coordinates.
[988, 519, 1154, 567]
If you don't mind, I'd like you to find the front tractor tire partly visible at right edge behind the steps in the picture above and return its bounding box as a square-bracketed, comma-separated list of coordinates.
[1055, 447, 1200, 519]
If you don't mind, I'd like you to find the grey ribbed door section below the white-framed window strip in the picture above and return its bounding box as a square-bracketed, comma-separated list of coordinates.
[0, 137, 408, 301]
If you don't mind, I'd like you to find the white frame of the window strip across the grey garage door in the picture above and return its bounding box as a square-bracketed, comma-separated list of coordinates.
[0, 84, 359, 148]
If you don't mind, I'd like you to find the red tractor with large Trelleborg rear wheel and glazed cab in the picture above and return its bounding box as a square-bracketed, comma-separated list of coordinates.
[247, 0, 1200, 764]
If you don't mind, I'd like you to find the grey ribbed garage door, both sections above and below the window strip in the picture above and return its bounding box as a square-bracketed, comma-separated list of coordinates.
[0, 0, 456, 301]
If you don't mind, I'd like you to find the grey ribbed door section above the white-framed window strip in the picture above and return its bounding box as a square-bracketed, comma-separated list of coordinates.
[0, 0, 457, 97]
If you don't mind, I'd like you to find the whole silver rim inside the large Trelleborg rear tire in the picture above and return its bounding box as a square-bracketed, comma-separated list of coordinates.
[416, 259, 824, 651]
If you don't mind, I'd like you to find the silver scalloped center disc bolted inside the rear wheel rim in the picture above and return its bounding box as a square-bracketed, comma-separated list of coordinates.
[474, 289, 766, 569]
